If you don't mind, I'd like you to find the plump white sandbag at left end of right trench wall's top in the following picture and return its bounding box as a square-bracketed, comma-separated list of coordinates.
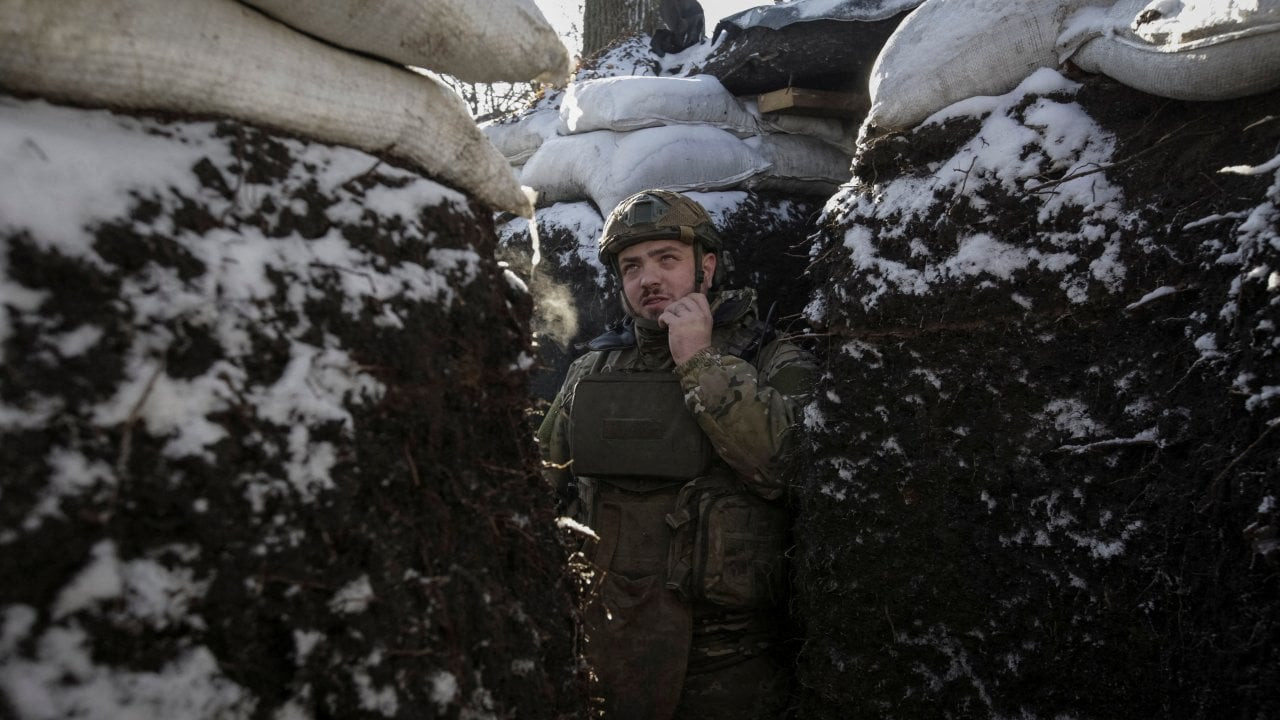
[864, 0, 1102, 131]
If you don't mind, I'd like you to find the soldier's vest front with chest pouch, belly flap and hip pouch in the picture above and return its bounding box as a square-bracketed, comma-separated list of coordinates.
[570, 363, 787, 609]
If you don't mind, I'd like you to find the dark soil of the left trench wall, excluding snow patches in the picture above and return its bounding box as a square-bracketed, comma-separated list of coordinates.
[0, 106, 584, 719]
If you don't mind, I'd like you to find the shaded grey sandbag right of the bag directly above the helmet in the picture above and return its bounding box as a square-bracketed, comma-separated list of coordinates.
[744, 133, 852, 195]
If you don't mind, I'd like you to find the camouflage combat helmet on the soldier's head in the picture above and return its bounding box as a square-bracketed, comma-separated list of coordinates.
[600, 190, 723, 273]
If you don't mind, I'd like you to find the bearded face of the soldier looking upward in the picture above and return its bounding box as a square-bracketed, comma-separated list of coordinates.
[618, 240, 716, 320]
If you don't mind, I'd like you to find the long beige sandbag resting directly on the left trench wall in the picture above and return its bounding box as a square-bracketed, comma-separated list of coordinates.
[0, 0, 531, 214]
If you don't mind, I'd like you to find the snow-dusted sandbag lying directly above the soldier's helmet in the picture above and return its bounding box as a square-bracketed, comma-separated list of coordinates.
[520, 126, 769, 215]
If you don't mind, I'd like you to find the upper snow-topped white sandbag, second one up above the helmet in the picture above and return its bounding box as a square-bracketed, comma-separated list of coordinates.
[561, 76, 758, 136]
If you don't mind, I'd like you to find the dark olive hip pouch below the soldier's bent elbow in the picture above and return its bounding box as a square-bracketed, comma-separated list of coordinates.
[667, 478, 788, 610]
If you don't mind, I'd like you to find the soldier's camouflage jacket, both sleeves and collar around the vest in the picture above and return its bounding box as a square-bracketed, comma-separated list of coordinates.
[538, 284, 817, 500]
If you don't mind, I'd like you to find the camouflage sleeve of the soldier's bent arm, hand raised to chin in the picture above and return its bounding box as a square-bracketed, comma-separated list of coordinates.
[676, 342, 818, 500]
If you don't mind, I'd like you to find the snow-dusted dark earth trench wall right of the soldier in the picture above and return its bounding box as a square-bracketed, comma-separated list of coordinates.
[794, 76, 1280, 720]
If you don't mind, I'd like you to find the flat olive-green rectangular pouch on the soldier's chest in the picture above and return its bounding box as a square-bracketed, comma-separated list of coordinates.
[570, 373, 713, 480]
